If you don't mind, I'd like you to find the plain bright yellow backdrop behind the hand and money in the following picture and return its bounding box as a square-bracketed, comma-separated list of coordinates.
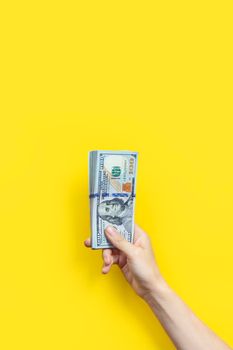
[0, 0, 233, 350]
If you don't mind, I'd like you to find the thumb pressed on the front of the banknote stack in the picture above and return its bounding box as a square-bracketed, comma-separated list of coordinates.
[104, 226, 134, 256]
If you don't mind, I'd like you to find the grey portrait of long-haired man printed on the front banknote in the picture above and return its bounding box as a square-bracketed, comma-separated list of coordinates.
[98, 197, 133, 232]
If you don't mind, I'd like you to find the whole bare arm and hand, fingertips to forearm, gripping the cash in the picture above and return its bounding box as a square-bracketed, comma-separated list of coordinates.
[84, 225, 231, 350]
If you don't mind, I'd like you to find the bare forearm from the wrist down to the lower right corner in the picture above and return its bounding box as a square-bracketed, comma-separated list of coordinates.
[145, 281, 230, 350]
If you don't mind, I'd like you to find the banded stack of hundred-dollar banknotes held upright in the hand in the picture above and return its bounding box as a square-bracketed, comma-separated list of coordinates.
[89, 151, 138, 249]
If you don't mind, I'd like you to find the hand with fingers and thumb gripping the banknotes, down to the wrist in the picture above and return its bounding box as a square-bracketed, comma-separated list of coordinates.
[84, 225, 164, 298]
